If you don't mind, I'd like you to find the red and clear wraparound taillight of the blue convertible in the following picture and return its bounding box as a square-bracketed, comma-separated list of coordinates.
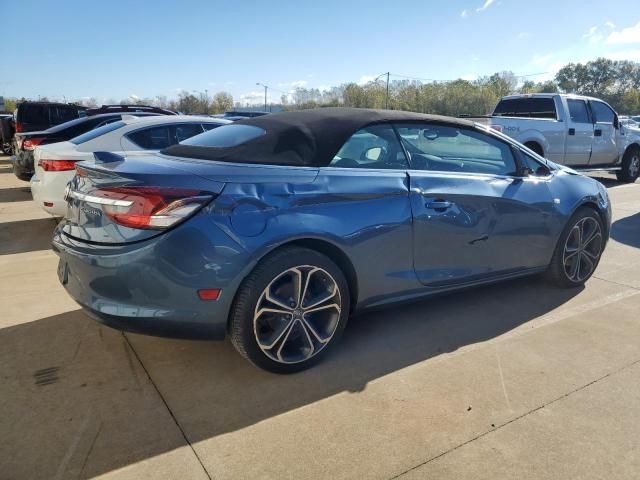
[70, 187, 213, 230]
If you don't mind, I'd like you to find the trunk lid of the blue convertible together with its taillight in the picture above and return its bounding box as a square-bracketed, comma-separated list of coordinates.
[62, 152, 224, 245]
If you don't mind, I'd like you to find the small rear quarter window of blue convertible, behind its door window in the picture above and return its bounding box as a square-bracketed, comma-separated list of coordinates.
[329, 125, 409, 170]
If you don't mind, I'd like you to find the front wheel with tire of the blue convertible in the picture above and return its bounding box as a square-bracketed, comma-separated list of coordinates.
[548, 207, 604, 288]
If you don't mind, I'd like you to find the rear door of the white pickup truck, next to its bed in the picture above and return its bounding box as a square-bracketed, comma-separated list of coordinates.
[561, 98, 594, 165]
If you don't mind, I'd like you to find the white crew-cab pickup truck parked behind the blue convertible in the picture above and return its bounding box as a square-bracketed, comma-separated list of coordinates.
[473, 93, 640, 182]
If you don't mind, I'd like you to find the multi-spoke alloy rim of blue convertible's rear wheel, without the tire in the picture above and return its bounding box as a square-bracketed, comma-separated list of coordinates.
[253, 265, 341, 364]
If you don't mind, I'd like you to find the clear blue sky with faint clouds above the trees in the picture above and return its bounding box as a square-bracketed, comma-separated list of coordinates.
[0, 0, 640, 104]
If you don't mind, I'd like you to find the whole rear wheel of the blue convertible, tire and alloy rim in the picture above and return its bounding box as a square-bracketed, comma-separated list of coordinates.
[229, 247, 349, 373]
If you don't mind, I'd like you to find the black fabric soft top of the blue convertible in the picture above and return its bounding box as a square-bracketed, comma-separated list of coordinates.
[161, 107, 473, 167]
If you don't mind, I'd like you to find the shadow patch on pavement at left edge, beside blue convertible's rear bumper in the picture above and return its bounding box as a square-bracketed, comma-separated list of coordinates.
[0, 217, 58, 255]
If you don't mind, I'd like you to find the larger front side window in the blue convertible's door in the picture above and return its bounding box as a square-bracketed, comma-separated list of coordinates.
[396, 124, 517, 175]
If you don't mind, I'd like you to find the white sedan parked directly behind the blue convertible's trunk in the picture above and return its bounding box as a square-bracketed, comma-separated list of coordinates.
[31, 115, 233, 216]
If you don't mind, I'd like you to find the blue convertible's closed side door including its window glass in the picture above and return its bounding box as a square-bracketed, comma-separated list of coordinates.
[396, 124, 553, 288]
